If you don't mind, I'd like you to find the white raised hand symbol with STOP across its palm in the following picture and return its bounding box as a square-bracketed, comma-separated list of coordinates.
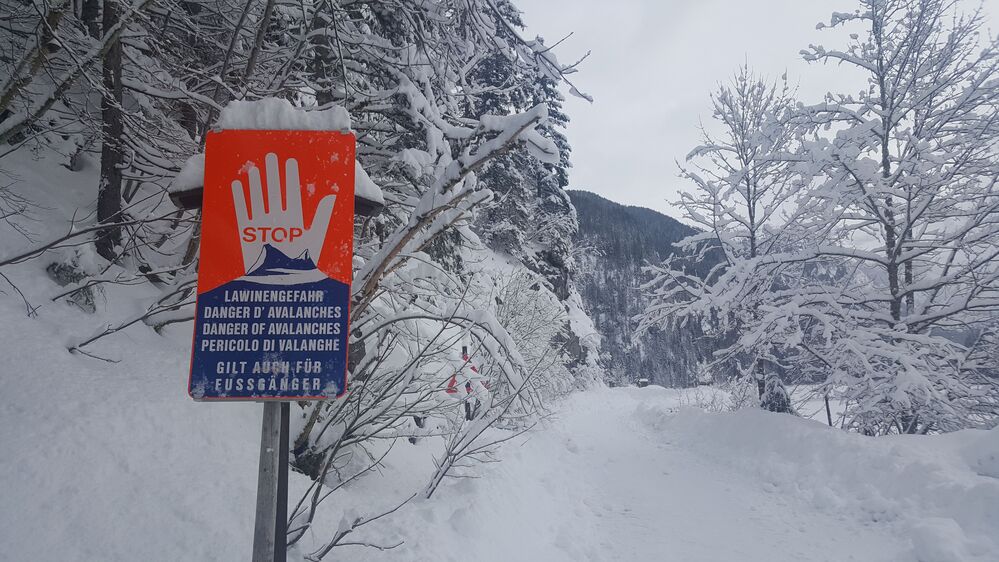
[232, 152, 336, 272]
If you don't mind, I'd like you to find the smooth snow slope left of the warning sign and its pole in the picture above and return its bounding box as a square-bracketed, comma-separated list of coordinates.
[0, 296, 266, 562]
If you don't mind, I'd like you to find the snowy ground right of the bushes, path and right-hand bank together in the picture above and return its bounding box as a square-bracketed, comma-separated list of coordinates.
[342, 387, 999, 562]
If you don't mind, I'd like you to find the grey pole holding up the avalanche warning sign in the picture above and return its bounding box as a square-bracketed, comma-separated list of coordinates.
[253, 402, 288, 562]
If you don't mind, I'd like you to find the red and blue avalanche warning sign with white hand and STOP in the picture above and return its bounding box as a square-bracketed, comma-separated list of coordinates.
[188, 130, 354, 400]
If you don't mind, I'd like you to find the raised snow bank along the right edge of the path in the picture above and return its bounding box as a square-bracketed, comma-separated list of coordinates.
[648, 407, 999, 562]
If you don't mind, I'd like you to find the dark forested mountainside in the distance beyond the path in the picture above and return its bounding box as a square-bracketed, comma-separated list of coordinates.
[568, 191, 712, 386]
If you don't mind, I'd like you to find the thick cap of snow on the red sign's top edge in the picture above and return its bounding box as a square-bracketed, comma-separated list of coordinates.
[217, 98, 350, 131]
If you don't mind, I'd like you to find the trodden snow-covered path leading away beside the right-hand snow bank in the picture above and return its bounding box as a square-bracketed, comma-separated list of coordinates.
[536, 388, 902, 561]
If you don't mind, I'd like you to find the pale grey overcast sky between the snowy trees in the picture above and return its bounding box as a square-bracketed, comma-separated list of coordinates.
[516, 0, 999, 216]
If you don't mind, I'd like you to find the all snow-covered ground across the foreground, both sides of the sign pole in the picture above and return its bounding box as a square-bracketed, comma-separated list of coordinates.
[0, 147, 999, 562]
